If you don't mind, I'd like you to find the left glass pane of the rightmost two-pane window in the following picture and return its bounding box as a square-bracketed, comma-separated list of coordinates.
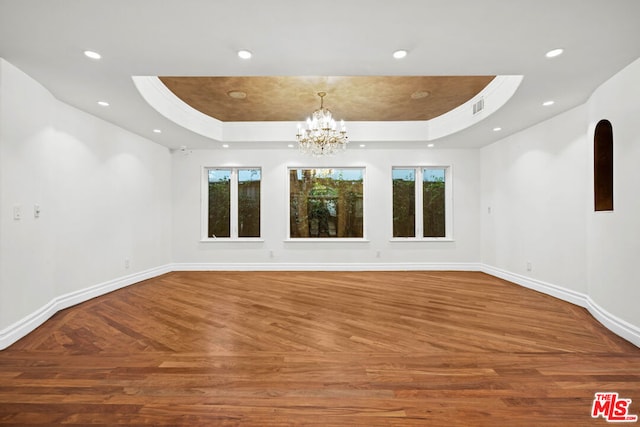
[392, 169, 416, 237]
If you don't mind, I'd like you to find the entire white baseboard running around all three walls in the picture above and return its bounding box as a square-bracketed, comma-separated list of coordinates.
[0, 263, 640, 350]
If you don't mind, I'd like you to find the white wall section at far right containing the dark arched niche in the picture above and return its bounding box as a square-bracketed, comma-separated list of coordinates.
[586, 59, 640, 333]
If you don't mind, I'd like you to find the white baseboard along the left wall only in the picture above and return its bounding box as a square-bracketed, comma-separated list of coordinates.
[0, 265, 171, 350]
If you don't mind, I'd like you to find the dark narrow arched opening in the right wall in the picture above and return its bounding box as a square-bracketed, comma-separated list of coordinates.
[593, 120, 613, 211]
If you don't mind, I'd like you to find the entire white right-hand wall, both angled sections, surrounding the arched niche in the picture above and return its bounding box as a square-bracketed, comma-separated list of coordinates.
[481, 56, 640, 346]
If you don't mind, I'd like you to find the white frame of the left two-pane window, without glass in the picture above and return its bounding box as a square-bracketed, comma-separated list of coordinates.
[200, 166, 264, 243]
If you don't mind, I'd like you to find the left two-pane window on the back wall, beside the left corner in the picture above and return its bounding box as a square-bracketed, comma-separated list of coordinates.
[204, 168, 261, 239]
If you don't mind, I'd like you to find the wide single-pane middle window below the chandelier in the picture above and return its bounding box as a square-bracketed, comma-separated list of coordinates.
[289, 168, 364, 238]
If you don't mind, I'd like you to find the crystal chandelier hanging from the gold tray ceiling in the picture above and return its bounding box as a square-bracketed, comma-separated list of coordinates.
[296, 92, 349, 156]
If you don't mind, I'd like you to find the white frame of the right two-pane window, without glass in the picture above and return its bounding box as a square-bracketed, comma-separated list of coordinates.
[389, 165, 454, 242]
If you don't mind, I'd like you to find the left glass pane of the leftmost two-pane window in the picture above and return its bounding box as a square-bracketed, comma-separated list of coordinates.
[208, 169, 231, 237]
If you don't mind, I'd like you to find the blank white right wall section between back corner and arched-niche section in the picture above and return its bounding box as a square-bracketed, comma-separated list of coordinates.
[481, 107, 589, 300]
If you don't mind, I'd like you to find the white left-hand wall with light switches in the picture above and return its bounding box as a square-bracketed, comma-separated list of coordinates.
[0, 59, 172, 348]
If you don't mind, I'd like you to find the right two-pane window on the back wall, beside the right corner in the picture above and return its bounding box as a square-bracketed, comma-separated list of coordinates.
[392, 167, 451, 239]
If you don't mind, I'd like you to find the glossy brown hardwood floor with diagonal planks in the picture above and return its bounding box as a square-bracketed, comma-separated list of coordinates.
[0, 272, 640, 426]
